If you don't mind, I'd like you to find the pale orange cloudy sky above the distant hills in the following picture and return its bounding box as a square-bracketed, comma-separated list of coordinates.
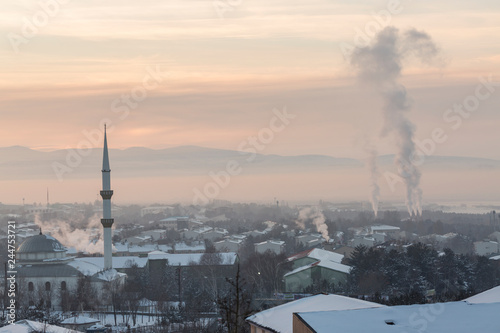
[0, 0, 500, 205]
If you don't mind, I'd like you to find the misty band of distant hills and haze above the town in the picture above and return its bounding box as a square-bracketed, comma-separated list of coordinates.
[0, 144, 500, 204]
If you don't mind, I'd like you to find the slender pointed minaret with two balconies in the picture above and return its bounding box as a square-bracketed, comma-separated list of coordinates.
[101, 125, 114, 269]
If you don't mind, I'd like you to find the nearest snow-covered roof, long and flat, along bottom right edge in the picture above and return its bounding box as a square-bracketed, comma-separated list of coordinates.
[297, 302, 500, 333]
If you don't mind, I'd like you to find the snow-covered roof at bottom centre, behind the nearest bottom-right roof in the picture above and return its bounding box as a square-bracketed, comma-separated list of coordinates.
[247, 295, 384, 333]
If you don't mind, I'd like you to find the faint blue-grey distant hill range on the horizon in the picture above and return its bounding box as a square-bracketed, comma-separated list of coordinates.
[0, 146, 500, 180]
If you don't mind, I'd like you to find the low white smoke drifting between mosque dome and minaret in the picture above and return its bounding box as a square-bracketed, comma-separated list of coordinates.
[35, 215, 104, 254]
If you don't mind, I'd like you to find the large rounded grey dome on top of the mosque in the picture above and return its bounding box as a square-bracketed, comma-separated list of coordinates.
[17, 233, 67, 263]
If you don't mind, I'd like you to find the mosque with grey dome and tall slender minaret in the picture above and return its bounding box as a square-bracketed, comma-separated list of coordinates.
[16, 128, 126, 310]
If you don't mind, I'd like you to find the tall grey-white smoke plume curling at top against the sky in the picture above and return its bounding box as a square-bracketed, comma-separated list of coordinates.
[351, 27, 438, 215]
